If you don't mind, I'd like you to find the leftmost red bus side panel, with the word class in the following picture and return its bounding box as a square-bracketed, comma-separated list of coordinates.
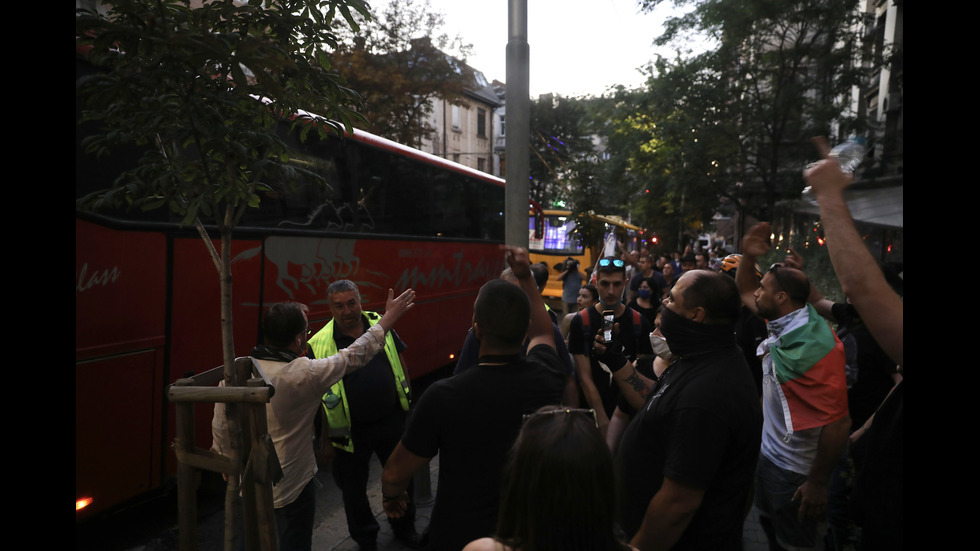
[75, 219, 166, 518]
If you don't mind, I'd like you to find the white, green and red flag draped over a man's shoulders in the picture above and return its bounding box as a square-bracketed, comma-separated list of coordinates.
[769, 303, 847, 432]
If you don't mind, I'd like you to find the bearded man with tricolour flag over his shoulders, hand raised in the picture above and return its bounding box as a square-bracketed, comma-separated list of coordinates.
[735, 222, 851, 549]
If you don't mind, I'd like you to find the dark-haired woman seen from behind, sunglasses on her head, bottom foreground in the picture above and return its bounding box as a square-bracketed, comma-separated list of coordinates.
[463, 406, 634, 551]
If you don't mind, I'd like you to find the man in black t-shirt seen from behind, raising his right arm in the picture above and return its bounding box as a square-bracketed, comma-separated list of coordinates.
[381, 248, 565, 550]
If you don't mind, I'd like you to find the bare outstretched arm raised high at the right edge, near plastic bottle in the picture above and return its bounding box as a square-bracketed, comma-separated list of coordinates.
[803, 138, 905, 371]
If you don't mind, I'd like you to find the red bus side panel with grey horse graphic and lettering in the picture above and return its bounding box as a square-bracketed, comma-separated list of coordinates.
[241, 236, 504, 377]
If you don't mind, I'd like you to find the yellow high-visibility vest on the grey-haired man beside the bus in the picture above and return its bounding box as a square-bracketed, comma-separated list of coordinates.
[308, 312, 410, 452]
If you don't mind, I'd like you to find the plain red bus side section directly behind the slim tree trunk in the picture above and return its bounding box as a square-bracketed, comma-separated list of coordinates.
[166, 237, 260, 473]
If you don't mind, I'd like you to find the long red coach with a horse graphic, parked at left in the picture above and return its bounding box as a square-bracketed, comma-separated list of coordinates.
[75, 68, 504, 520]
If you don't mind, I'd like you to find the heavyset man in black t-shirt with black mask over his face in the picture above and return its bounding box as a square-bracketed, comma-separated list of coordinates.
[614, 270, 762, 550]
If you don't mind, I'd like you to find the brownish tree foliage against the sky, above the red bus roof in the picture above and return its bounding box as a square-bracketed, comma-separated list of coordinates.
[333, 0, 474, 147]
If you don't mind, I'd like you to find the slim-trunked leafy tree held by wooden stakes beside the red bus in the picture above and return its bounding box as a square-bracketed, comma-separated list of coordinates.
[76, 0, 367, 549]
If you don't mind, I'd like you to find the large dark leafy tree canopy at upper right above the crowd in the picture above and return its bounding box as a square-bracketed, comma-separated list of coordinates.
[615, 0, 862, 235]
